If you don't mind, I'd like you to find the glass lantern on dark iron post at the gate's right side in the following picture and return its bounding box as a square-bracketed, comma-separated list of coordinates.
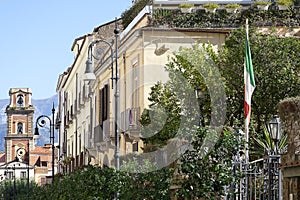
[267, 115, 281, 200]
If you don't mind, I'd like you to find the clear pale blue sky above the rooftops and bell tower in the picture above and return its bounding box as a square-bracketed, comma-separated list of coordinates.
[0, 0, 132, 99]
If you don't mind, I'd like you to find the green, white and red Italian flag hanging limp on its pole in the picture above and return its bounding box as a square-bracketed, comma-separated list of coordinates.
[244, 24, 255, 129]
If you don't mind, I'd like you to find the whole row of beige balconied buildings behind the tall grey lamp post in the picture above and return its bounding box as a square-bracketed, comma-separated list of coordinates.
[57, 2, 230, 172]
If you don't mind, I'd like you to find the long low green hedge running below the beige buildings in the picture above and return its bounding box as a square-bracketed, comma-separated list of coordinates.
[31, 164, 173, 200]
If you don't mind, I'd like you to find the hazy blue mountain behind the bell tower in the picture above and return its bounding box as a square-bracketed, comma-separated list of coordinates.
[0, 95, 58, 151]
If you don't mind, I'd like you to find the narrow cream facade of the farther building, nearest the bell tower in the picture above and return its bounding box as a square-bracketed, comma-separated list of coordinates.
[56, 35, 90, 172]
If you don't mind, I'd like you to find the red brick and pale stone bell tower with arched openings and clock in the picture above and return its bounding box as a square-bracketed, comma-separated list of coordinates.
[5, 88, 34, 162]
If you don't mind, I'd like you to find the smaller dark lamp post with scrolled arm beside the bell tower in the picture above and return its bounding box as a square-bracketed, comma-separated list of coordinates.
[34, 103, 55, 183]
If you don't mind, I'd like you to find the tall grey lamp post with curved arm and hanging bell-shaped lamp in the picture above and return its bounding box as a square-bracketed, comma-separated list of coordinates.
[84, 20, 120, 170]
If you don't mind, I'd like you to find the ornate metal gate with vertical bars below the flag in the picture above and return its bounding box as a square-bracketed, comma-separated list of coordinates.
[224, 152, 282, 200]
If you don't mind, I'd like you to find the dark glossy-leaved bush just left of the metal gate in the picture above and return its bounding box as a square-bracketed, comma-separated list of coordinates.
[177, 128, 239, 199]
